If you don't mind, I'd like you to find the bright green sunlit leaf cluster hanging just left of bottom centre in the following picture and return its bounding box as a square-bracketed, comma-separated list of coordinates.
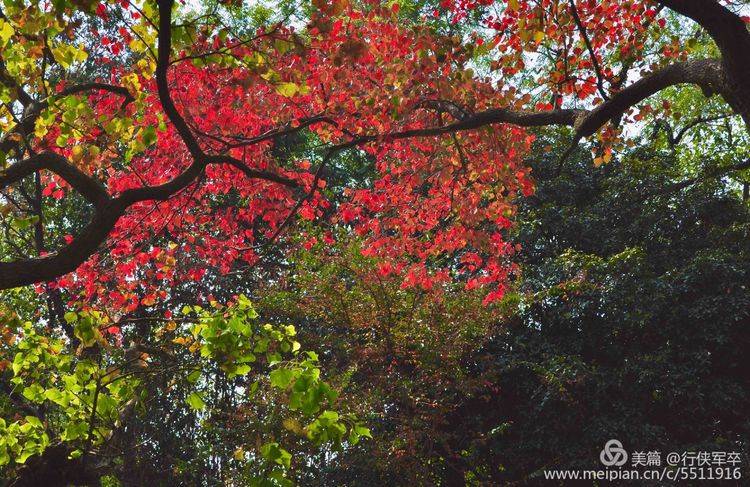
[175, 295, 371, 485]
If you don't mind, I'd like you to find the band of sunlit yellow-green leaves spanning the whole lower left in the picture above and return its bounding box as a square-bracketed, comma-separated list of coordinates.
[0, 296, 371, 485]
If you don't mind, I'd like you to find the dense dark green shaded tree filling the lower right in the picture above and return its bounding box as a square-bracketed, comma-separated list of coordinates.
[280, 143, 750, 485]
